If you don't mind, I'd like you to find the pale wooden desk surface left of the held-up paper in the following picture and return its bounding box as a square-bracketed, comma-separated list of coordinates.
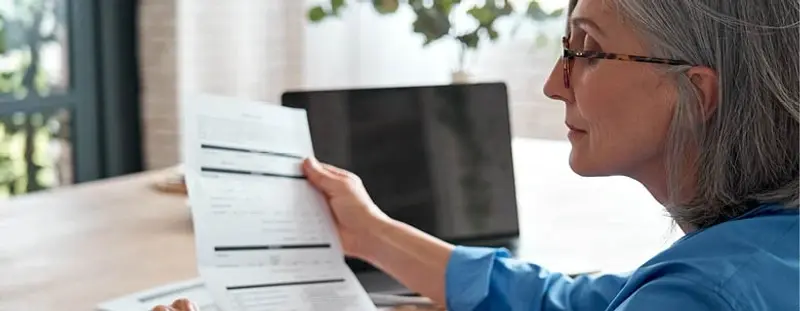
[0, 173, 197, 311]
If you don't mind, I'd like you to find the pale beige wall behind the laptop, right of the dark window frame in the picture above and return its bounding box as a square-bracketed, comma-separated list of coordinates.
[140, 0, 566, 168]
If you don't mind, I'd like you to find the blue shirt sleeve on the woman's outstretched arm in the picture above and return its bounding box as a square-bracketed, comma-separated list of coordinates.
[445, 246, 628, 311]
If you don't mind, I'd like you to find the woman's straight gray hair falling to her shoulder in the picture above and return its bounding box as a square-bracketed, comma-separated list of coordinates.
[571, 0, 800, 229]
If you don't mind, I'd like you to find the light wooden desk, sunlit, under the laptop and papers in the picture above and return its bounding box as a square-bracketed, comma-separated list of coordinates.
[0, 140, 677, 311]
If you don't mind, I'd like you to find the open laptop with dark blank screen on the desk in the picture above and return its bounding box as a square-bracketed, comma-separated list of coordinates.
[281, 83, 519, 294]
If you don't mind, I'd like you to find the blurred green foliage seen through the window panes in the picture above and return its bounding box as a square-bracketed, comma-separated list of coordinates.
[0, 0, 71, 199]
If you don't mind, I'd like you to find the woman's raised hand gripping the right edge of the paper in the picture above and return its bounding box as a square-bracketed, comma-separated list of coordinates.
[303, 158, 390, 259]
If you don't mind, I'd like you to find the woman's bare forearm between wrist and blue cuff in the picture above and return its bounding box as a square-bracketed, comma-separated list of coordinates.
[361, 220, 455, 304]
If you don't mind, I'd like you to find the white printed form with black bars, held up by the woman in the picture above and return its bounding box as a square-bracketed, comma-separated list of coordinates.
[182, 95, 376, 311]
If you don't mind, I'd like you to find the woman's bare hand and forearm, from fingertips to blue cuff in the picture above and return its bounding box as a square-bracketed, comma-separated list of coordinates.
[303, 159, 454, 304]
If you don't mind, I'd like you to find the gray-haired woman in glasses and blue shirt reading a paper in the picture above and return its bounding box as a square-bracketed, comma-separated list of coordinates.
[153, 0, 800, 311]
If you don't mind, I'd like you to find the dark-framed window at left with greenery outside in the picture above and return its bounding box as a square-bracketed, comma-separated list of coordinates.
[0, 0, 140, 198]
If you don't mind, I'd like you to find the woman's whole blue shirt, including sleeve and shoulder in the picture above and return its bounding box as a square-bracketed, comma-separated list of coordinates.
[446, 205, 800, 311]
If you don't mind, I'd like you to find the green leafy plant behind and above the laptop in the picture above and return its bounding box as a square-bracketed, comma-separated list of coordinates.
[308, 0, 564, 83]
